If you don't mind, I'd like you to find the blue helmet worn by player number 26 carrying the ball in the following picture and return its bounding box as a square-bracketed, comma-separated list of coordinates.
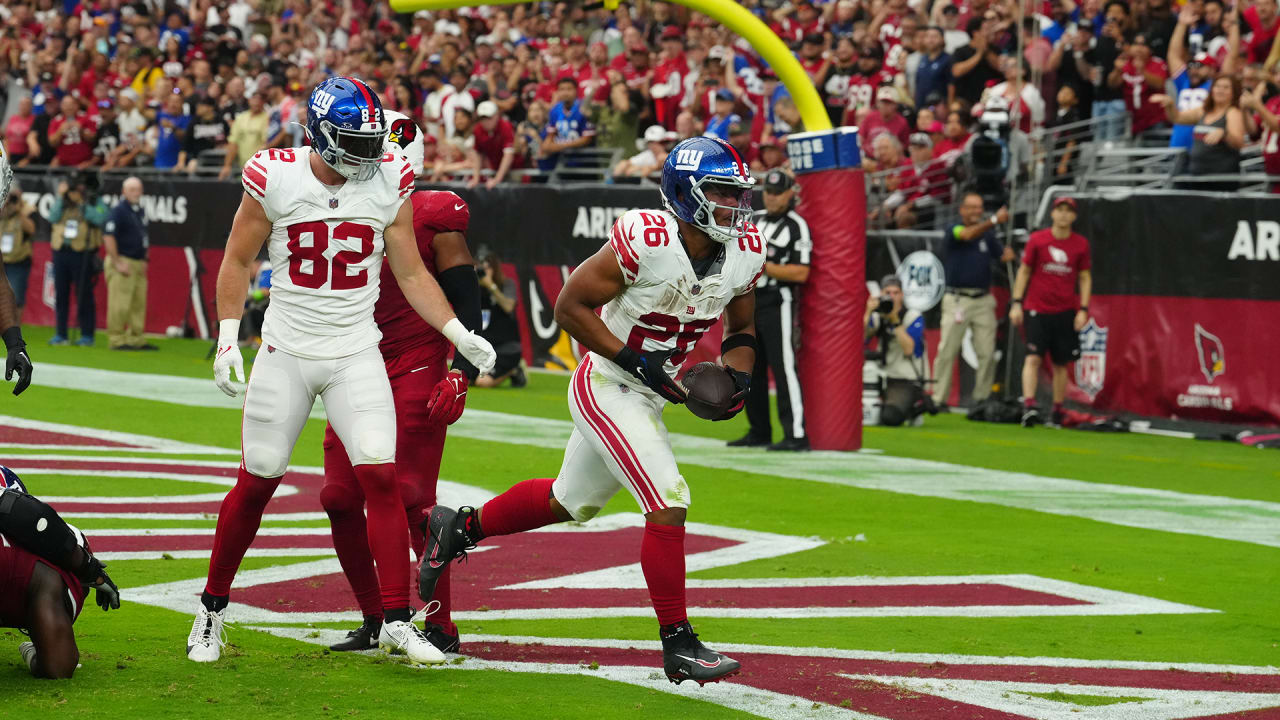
[662, 137, 755, 242]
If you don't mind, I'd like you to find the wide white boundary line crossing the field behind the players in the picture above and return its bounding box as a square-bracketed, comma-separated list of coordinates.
[27, 363, 1280, 547]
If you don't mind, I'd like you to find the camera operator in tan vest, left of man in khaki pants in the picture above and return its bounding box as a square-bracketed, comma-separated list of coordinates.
[49, 172, 108, 346]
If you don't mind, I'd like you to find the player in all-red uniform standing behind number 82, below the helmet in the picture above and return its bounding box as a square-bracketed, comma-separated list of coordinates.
[320, 191, 480, 652]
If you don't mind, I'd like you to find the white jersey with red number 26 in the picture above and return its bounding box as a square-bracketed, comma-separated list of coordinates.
[593, 210, 764, 395]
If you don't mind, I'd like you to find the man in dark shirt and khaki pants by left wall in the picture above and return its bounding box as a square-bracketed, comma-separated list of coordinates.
[102, 177, 156, 350]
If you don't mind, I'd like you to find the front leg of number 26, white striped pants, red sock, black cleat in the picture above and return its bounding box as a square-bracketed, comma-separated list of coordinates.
[557, 359, 740, 684]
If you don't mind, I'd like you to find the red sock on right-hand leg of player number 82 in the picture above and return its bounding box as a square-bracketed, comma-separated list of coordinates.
[356, 464, 408, 610]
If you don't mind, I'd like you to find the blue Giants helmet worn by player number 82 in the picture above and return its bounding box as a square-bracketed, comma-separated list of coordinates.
[307, 77, 387, 182]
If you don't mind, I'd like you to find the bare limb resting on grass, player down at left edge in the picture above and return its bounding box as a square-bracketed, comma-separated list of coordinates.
[22, 562, 79, 679]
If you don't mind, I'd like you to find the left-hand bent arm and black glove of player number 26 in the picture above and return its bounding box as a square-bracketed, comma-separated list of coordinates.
[556, 243, 685, 402]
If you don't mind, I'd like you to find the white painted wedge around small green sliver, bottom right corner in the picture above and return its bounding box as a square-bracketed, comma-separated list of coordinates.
[840, 673, 1280, 720]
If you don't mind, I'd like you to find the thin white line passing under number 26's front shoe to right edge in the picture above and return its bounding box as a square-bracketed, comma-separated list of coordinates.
[448, 634, 1280, 675]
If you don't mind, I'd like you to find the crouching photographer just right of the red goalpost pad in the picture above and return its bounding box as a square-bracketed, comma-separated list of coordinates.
[863, 275, 925, 425]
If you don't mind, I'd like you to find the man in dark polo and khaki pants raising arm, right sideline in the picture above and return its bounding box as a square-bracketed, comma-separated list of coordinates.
[933, 192, 1014, 406]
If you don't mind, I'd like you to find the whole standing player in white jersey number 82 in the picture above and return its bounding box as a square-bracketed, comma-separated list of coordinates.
[187, 77, 495, 662]
